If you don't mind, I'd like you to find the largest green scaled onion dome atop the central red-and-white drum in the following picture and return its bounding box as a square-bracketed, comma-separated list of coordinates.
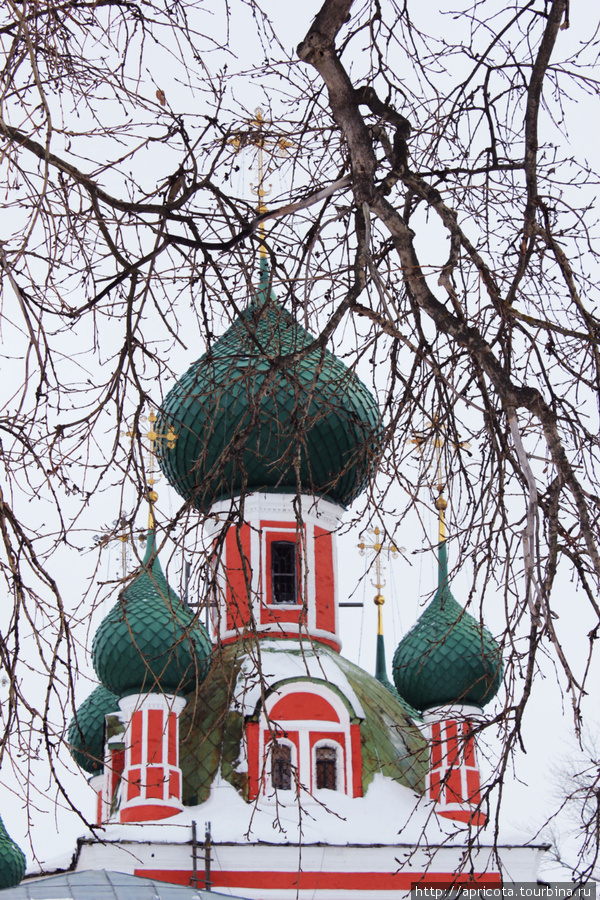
[157, 261, 381, 510]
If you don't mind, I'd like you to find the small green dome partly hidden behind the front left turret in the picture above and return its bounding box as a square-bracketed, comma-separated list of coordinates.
[68, 684, 119, 775]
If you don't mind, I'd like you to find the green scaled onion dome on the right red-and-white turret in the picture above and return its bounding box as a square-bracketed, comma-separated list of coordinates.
[393, 542, 503, 710]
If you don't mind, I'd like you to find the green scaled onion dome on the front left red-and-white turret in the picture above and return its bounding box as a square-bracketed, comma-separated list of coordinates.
[92, 532, 212, 697]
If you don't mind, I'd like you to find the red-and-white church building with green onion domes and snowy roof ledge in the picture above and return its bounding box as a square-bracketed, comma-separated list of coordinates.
[5, 258, 542, 900]
